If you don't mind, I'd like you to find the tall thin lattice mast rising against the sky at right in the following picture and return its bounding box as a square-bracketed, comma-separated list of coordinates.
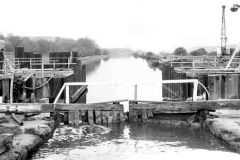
[221, 6, 227, 56]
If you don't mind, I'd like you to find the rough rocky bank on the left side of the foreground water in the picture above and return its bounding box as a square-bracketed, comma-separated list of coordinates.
[0, 113, 55, 160]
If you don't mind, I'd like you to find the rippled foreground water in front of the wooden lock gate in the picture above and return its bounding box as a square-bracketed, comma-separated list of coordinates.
[31, 123, 240, 160]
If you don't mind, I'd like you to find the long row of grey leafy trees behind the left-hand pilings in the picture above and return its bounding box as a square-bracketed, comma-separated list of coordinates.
[0, 34, 109, 56]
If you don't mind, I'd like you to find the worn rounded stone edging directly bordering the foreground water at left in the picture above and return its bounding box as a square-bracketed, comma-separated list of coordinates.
[0, 114, 55, 160]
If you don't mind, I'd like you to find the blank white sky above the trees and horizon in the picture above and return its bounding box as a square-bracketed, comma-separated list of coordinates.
[0, 0, 240, 52]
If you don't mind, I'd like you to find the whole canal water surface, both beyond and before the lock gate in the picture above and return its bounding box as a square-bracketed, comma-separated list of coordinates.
[29, 56, 240, 160]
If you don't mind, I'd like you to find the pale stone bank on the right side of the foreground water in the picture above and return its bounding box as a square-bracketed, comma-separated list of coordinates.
[205, 110, 240, 153]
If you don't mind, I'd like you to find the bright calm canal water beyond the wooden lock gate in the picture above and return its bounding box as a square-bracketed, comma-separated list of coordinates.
[86, 56, 162, 111]
